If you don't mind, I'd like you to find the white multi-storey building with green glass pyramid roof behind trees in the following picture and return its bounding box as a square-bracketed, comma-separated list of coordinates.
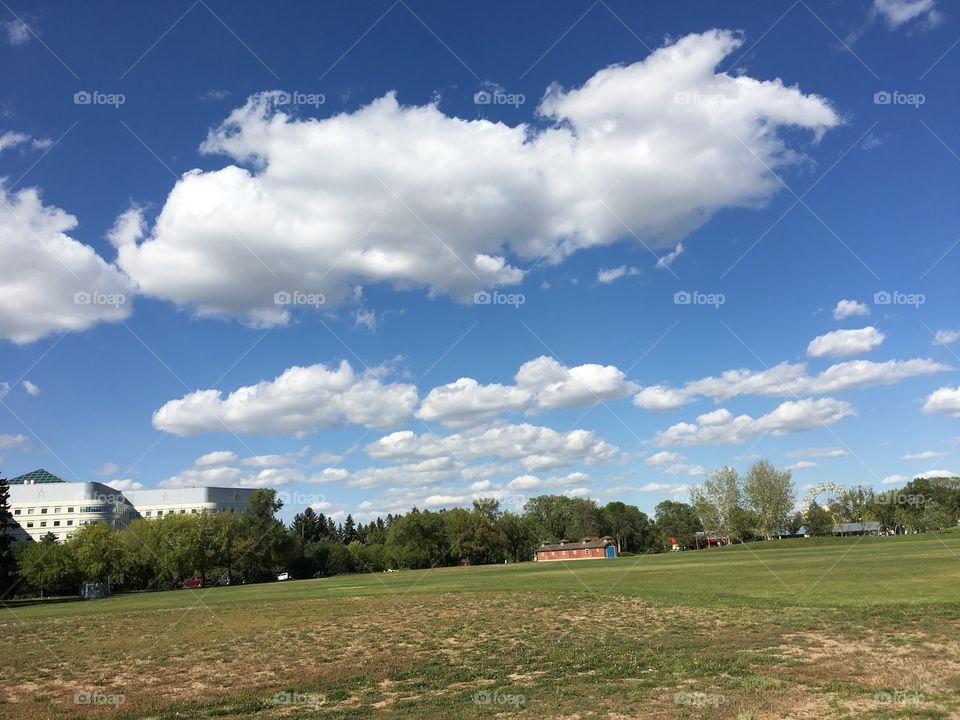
[7, 470, 254, 540]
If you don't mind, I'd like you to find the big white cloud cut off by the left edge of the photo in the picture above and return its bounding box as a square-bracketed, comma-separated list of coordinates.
[0, 188, 133, 344]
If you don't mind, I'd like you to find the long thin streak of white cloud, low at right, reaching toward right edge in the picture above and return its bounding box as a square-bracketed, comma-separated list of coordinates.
[633, 358, 952, 412]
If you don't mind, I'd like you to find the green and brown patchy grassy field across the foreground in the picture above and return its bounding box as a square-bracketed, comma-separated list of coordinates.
[0, 533, 960, 720]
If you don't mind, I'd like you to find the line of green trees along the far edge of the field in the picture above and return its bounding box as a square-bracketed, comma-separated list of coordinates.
[0, 460, 960, 598]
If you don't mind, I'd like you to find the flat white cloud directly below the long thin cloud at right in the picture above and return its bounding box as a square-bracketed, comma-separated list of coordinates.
[655, 398, 854, 447]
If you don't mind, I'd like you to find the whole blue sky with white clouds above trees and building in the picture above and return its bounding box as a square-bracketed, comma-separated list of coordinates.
[0, 0, 960, 519]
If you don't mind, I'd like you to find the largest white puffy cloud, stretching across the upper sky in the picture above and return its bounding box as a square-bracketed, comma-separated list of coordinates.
[109, 30, 839, 325]
